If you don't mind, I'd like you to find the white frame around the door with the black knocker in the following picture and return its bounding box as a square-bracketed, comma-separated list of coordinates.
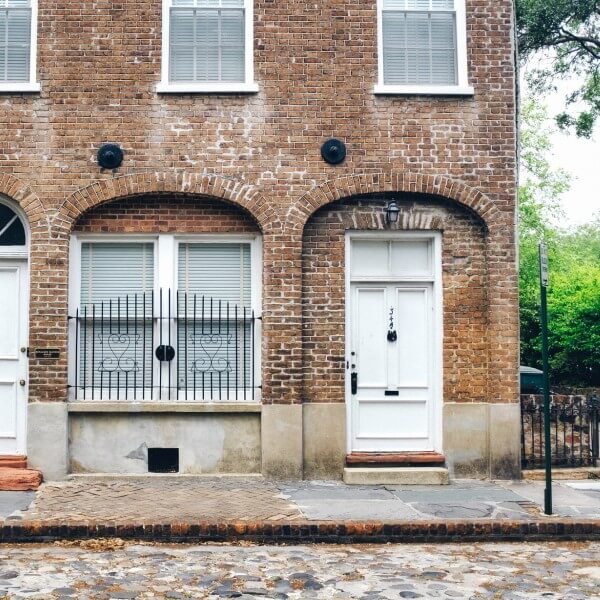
[345, 231, 444, 453]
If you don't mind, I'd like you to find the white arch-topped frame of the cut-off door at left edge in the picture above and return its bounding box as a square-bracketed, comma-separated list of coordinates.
[0, 196, 31, 455]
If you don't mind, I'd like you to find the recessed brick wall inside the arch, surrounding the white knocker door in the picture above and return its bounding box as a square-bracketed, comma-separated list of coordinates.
[302, 197, 488, 402]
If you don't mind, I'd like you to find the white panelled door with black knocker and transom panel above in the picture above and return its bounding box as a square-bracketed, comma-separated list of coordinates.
[348, 236, 441, 452]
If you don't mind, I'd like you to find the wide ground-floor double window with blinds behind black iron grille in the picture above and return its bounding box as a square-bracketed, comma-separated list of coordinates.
[69, 234, 260, 401]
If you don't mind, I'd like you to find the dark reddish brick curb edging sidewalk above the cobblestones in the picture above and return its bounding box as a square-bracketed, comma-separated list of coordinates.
[0, 519, 600, 544]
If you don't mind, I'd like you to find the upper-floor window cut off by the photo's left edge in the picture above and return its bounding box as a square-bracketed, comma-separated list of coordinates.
[0, 0, 39, 92]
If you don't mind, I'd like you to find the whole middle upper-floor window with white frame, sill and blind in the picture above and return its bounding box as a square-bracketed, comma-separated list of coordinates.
[158, 0, 257, 92]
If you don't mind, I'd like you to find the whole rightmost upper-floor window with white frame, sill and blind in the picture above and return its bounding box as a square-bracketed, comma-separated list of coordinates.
[375, 0, 473, 94]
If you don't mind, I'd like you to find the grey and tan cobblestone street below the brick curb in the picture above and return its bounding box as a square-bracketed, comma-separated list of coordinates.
[0, 540, 600, 600]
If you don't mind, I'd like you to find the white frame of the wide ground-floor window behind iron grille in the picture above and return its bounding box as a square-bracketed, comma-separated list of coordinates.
[68, 232, 262, 405]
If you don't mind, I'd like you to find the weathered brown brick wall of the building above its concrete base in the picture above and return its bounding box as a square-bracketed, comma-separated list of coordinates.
[0, 0, 518, 402]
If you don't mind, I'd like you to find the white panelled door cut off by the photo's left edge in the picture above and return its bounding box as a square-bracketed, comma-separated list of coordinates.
[0, 259, 28, 454]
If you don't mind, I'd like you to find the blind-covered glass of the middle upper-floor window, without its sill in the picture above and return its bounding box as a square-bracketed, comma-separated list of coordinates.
[169, 0, 246, 83]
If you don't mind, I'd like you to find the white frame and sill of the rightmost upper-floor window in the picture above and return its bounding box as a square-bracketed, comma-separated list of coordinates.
[373, 0, 475, 96]
